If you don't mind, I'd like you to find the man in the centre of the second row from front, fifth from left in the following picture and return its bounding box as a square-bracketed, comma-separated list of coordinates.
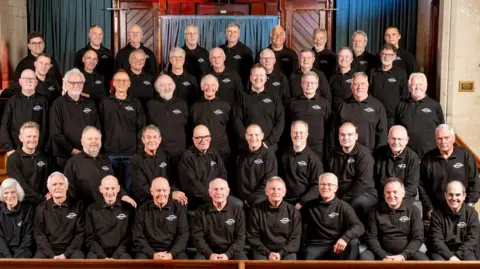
[235, 124, 277, 206]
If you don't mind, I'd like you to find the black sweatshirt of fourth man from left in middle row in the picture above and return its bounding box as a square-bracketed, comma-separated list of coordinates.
[147, 96, 188, 158]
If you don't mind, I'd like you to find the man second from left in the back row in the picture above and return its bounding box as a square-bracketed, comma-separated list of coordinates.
[73, 24, 114, 87]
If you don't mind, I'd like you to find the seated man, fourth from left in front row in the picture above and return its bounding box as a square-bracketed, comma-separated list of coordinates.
[132, 177, 190, 260]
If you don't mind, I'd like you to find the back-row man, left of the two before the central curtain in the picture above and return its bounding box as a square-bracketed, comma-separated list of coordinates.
[182, 24, 210, 81]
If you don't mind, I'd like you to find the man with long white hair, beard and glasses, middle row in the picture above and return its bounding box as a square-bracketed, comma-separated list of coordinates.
[50, 68, 100, 171]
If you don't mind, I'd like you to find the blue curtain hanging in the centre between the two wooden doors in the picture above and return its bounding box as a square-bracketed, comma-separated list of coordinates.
[160, 16, 278, 63]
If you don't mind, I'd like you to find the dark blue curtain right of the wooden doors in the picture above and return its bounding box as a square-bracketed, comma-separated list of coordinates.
[335, 0, 418, 54]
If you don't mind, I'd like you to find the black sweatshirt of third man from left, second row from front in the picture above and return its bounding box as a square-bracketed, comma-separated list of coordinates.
[131, 149, 173, 204]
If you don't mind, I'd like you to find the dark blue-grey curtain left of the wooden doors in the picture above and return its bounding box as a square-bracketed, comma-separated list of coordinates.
[27, 0, 112, 73]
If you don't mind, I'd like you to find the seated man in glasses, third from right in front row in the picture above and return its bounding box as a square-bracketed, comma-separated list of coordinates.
[302, 173, 365, 260]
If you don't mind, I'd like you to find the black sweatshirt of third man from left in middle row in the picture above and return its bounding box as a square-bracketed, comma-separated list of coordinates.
[98, 95, 145, 156]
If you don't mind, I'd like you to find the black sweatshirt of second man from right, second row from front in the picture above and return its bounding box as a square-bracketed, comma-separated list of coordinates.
[373, 145, 420, 201]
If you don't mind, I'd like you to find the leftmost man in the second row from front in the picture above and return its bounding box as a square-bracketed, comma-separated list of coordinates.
[7, 121, 51, 206]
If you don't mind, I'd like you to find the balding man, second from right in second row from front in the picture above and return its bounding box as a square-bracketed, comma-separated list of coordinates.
[373, 125, 420, 202]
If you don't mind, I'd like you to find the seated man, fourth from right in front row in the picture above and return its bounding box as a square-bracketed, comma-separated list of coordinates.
[247, 177, 302, 261]
